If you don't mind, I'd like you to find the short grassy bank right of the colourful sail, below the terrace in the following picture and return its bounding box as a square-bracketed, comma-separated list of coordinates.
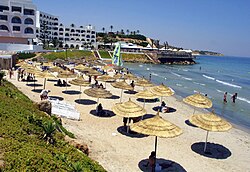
[122, 53, 151, 63]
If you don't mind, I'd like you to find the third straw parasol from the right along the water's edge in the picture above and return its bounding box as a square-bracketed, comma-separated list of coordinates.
[149, 84, 174, 99]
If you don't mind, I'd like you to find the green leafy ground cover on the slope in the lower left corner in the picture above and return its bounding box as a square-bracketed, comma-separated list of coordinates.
[0, 81, 105, 171]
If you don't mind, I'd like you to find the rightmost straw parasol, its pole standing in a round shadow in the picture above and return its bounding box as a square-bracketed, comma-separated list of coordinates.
[189, 112, 232, 152]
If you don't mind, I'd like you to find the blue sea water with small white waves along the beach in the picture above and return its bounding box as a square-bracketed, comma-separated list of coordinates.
[124, 56, 250, 131]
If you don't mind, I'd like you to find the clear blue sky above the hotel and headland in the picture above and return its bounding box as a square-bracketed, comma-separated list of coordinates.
[33, 0, 250, 57]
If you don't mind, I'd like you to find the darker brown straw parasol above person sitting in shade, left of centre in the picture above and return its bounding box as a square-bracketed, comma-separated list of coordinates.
[84, 88, 112, 104]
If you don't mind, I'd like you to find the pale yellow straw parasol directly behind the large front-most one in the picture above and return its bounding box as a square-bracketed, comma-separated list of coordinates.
[112, 98, 147, 132]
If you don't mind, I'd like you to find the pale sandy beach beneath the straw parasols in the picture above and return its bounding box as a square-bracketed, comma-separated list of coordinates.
[5, 70, 250, 172]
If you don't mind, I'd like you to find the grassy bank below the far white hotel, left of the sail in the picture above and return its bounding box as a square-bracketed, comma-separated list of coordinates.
[41, 50, 95, 61]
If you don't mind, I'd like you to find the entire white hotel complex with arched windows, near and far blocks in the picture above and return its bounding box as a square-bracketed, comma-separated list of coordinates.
[0, 0, 96, 51]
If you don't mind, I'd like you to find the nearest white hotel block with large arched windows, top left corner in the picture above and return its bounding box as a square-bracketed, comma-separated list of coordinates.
[0, 0, 36, 45]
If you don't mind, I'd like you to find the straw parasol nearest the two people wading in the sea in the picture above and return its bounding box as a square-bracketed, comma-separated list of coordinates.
[183, 93, 213, 114]
